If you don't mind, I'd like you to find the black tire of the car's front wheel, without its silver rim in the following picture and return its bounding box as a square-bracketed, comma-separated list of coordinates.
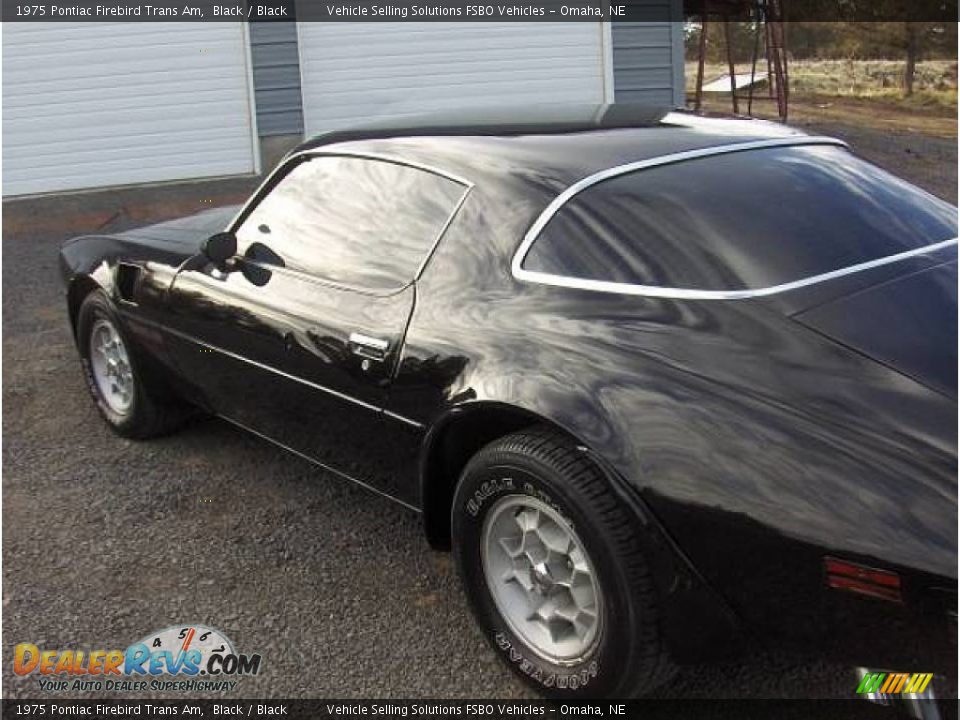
[76, 290, 189, 440]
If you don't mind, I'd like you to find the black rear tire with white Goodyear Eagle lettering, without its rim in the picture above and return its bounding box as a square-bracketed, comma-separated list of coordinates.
[451, 428, 674, 700]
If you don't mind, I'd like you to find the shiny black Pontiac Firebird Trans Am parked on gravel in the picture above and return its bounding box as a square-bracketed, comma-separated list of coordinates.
[61, 106, 957, 698]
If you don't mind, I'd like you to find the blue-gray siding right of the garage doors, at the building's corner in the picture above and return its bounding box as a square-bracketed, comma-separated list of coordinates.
[611, 0, 684, 106]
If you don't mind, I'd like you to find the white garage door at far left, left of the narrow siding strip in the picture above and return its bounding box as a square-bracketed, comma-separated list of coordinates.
[3, 23, 258, 196]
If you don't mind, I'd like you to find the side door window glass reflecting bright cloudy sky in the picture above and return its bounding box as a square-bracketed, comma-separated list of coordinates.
[237, 155, 468, 292]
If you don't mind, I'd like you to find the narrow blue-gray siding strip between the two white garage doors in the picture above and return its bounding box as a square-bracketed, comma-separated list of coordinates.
[250, 22, 303, 137]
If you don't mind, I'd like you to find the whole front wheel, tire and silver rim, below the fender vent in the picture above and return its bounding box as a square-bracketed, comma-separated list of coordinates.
[77, 290, 188, 438]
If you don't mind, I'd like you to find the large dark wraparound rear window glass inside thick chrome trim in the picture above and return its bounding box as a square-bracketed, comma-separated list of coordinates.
[522, 146, 957, 291]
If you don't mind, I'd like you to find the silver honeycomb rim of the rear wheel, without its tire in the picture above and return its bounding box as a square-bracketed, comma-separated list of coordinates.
[481, 495, 603, 665]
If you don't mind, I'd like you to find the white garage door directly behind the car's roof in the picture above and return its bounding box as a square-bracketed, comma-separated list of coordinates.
[299, 22, 612, 135]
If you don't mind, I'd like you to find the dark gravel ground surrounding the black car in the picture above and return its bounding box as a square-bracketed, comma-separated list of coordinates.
[2, 125, 957, 710]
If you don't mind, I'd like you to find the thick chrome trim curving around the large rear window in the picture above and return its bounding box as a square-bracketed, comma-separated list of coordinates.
[510, 136, 958, 300]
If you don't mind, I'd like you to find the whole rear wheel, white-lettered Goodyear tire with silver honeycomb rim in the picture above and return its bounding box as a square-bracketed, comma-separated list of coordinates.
[452, 429, 672, 699]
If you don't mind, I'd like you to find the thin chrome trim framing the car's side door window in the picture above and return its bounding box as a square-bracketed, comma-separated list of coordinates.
[225, 148, 475, 297]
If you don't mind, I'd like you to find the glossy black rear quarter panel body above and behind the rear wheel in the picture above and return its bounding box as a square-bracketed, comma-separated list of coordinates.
[391, 181, 957, 664]
